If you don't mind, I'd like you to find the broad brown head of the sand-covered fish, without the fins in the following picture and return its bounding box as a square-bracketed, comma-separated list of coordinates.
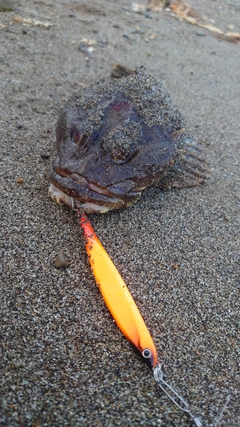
[50, 86, 176, 213]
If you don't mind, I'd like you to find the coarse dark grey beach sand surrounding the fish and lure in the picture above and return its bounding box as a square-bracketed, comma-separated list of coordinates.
[0, 0, 240, 427]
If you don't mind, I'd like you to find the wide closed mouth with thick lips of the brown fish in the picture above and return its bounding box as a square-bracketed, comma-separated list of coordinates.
[49, 169, 142, 213]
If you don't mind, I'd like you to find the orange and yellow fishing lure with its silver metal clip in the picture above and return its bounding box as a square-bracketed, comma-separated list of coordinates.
[78, 210, 202, 427]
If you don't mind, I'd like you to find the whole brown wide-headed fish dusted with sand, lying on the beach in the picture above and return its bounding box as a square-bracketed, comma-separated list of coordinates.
[49, 68, 208, 214]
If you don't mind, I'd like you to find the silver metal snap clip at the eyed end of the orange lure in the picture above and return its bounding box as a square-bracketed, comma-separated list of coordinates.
[153, 363, 202, 427]
